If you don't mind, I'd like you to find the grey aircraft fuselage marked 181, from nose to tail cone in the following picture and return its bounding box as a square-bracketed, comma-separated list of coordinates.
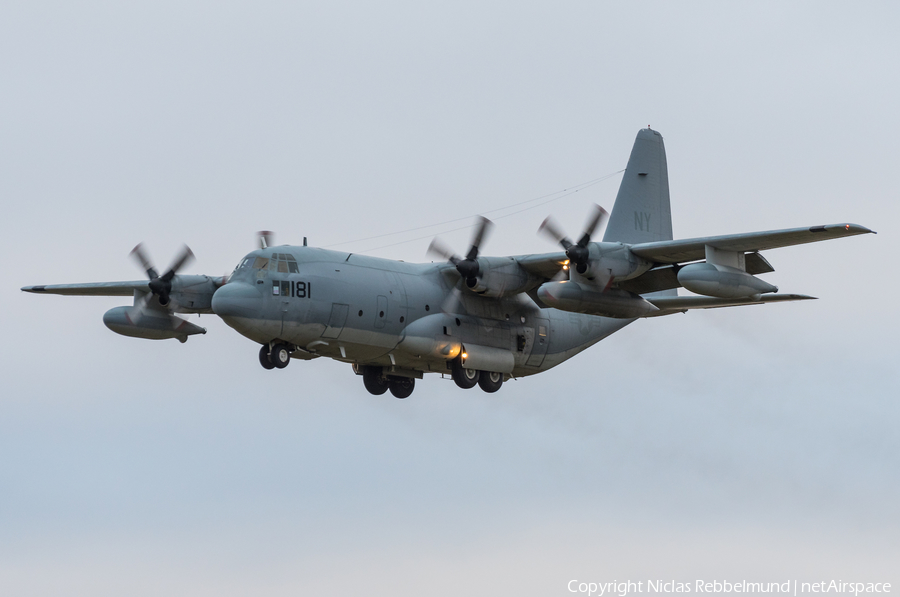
[213, 246, 634, 377]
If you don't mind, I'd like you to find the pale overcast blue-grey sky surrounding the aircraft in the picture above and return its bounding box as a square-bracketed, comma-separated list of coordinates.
[0, 2, 900, 596]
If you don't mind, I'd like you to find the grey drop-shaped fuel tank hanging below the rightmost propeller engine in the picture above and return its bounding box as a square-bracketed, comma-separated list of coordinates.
[538, 281, 659, 319]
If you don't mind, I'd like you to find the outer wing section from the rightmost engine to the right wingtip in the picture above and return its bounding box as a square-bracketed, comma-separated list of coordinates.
[631, 224, 873, 263]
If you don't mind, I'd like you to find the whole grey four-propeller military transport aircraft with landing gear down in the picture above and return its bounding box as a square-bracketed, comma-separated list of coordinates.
[22, 128, 872, 398]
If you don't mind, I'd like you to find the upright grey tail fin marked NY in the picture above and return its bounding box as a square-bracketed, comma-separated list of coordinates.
[603, 128, 672, 244]
